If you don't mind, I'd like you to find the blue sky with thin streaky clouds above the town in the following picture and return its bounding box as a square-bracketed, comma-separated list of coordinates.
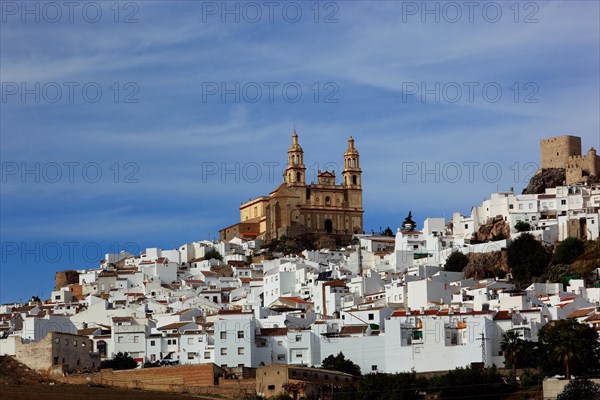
[0, 1, 600, 303]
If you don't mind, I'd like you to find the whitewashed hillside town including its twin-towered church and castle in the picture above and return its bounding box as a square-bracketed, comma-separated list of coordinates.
[0, 132, 600, 396]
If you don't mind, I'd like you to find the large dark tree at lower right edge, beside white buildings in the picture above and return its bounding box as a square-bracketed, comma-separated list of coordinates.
[539, 319, 600, 378]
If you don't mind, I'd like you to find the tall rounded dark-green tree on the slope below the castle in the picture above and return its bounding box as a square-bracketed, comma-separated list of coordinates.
[508, 233, 549, 286]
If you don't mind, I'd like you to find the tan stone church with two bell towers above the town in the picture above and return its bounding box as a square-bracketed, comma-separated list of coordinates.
[219, 130, 363, 243]
